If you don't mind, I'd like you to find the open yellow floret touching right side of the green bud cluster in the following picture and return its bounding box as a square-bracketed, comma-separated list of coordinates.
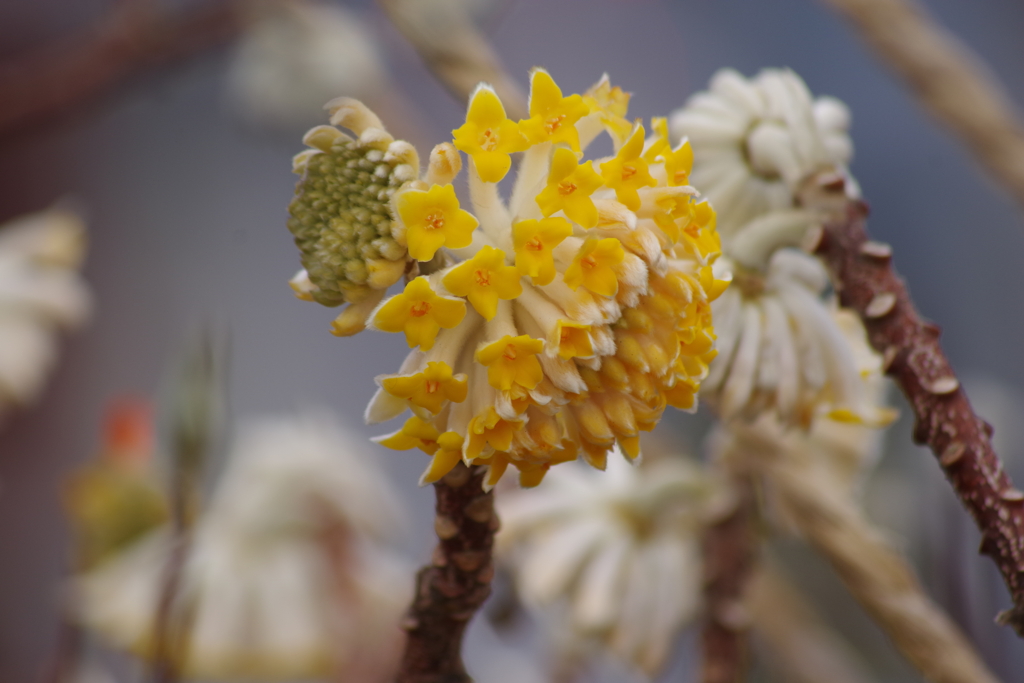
[395, 184, 479, 261]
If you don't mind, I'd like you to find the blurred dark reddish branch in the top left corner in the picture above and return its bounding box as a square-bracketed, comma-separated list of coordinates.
[0, 0, 244, 139]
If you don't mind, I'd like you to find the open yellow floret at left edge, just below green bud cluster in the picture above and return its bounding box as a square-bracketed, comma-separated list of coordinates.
[373, 276, 466, 351]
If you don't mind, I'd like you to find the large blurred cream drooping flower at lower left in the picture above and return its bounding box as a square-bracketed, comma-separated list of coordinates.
[76, 417, 412, 682]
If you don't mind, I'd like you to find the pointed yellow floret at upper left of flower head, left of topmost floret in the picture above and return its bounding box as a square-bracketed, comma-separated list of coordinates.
[452, 84, 529, 182]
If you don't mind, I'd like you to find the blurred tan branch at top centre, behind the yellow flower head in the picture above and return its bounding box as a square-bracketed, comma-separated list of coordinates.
[379, 0, 528, 119]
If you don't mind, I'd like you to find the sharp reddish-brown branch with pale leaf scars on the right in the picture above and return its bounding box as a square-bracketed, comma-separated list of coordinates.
[815, 197, 1024, 637]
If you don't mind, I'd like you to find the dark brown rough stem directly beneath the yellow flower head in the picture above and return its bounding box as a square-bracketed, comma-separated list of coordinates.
[396, 463, 499, 683]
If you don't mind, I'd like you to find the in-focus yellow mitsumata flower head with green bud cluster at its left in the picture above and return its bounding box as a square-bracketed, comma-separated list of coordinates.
[292, 69, 728, 487]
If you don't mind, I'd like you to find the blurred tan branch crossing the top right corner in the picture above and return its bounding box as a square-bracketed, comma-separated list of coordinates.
[823, 0, 1024, 214]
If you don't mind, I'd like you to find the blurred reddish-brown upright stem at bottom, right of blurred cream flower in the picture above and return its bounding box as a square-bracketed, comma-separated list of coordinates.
[700, 476, 757, 683]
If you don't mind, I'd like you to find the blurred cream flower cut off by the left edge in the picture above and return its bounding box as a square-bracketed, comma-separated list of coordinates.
[0, 209, 91, 416]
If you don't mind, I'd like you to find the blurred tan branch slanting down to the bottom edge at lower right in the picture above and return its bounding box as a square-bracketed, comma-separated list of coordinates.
[727, 419, 998, 683]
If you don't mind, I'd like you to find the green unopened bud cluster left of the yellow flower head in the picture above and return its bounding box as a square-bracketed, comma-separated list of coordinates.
[288, 135, 411, 306]
